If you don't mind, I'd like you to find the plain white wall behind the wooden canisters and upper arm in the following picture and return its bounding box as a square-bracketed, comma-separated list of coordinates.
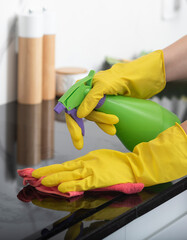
[0, 0, 187, 104]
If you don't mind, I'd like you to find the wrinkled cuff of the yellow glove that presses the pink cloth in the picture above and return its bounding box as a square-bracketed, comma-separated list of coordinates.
[130, 123, 187, 186]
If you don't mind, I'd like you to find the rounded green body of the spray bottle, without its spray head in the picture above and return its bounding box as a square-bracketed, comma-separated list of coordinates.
[97, 95, 180, 151]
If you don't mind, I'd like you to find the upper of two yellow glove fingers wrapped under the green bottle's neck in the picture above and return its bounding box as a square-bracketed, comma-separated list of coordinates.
[86, 111, 119, 124]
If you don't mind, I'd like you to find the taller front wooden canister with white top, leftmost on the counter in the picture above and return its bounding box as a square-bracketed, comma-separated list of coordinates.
[18, 10, 43, 104]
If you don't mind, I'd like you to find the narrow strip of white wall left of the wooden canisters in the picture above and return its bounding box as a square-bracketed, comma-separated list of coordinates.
[0, 0, 20, 104]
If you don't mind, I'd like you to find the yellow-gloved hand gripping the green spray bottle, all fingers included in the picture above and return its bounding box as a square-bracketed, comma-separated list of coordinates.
[66, 50, 165, 150]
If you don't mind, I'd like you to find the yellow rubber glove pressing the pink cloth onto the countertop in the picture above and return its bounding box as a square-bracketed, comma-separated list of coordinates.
[32, 123, 187, 193]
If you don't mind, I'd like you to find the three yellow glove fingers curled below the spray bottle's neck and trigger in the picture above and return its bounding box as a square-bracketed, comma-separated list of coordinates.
[65, 111, 119, 150]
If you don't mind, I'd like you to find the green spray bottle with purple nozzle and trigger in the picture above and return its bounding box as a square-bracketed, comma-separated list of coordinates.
[54, 70, 180, 151]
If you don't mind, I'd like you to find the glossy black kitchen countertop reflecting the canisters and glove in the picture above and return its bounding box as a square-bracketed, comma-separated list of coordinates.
[0, 81, 187, 240]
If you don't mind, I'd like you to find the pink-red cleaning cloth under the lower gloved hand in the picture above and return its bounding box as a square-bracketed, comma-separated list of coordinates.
[17, 168, 144, 198]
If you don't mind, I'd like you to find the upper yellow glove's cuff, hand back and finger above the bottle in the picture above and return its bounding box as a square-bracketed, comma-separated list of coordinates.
[77, 50, 166, 118]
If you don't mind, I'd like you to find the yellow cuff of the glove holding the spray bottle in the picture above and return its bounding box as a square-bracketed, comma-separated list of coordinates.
[116, 50, 166, 99]
